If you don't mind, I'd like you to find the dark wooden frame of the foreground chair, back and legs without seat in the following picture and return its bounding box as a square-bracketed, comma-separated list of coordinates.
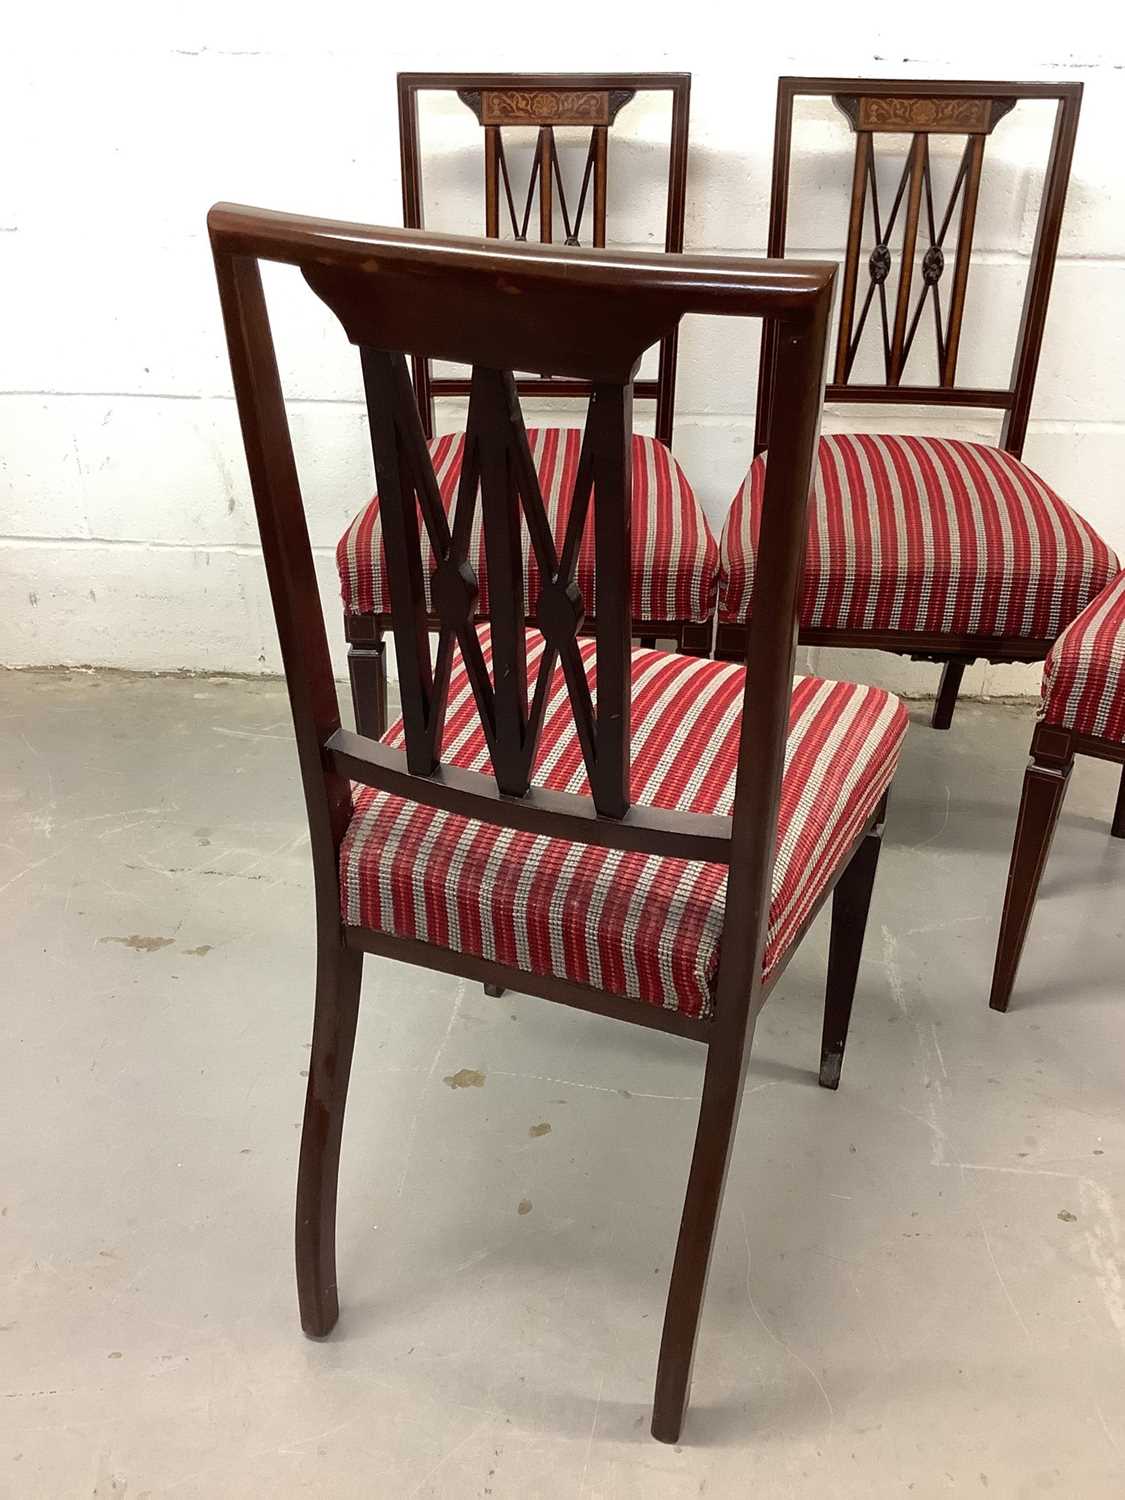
[209, 206, 900, 1442]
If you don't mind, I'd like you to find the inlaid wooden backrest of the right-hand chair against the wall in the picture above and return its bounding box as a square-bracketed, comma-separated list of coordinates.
[756, 78, 1082, 458]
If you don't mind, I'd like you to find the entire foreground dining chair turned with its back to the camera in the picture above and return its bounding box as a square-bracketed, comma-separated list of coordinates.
[209, 206, 905, 1442]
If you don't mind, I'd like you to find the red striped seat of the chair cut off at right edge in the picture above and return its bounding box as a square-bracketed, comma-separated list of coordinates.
[1040, 573, 1125, 744]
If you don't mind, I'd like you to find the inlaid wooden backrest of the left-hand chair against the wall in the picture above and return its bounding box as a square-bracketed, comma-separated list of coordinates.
[399, 74, 692, 446]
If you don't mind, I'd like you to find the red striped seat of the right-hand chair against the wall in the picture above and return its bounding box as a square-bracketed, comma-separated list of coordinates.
[720, 434, 1119, 641]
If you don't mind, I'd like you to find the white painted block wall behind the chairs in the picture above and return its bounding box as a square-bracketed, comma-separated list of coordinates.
[0, 0, 1125, 692]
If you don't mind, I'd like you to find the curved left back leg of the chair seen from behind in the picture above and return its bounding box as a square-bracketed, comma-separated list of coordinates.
[297, 941, 363, 1338]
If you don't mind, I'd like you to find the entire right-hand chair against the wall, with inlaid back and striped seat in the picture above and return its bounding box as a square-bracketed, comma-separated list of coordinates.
[719, 78, 1118, 729]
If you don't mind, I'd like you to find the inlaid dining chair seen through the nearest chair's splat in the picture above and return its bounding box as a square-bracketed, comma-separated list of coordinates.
[338, 74, 719, 735]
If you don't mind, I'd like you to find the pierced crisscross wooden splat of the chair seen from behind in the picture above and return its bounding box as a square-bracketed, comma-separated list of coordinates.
[362, 347, 632, 818]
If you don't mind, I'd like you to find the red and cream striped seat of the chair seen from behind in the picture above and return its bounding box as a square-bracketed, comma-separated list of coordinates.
[341, 627, 906, 1016]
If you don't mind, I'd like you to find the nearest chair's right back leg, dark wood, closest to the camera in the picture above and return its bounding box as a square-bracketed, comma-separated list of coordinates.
[653, 1028, 753, 1443]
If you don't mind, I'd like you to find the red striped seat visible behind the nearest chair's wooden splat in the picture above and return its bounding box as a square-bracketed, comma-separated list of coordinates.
[336, 428, 719, 623]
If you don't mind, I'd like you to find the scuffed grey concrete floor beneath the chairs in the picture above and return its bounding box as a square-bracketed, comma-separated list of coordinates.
[0, 672, 1125, 1500]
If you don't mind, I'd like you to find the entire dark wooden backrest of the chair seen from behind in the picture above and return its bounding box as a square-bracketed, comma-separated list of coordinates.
[209, 204, 836, 1025]
